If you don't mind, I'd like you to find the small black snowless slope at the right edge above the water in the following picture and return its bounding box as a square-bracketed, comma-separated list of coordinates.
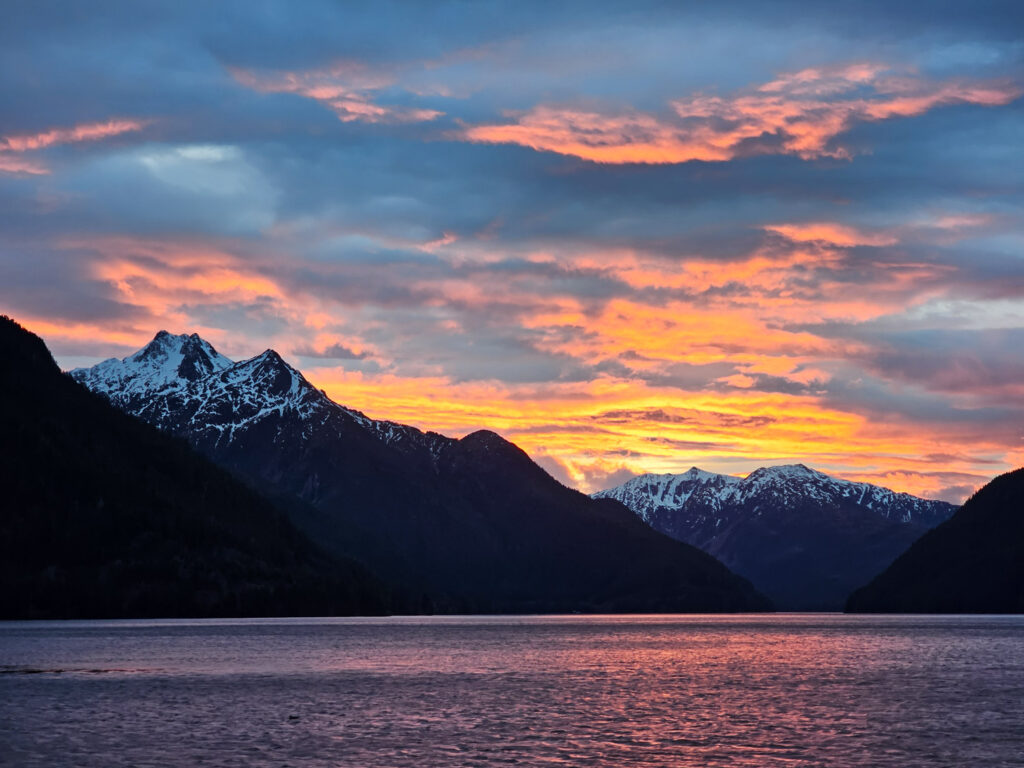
[846, 469, 1024, 613]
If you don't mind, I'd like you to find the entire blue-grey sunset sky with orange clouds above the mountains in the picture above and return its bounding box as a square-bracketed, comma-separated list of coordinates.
[0, 0, 1024, 502]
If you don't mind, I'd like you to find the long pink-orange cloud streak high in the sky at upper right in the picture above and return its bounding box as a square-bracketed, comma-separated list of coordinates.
[459, 63, 1021, 164]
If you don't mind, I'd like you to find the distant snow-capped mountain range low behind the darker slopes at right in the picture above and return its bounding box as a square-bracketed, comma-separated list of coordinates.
[594, 464, 955, 610]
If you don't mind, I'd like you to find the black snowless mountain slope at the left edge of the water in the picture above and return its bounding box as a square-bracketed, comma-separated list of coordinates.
[0, 316, 391, 618]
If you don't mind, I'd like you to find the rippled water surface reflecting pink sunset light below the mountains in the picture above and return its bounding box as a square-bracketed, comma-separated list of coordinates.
[0, 614, 1024, 768]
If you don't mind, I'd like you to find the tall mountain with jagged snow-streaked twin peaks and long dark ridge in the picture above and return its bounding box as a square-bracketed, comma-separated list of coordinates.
[72, 332, 768, 612]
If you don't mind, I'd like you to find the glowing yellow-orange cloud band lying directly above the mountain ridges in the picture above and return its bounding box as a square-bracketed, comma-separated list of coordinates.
[306, 368, 1009, 496]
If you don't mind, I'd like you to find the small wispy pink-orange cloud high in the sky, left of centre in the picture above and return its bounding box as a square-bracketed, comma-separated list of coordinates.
[230, 62, 442, 123]
